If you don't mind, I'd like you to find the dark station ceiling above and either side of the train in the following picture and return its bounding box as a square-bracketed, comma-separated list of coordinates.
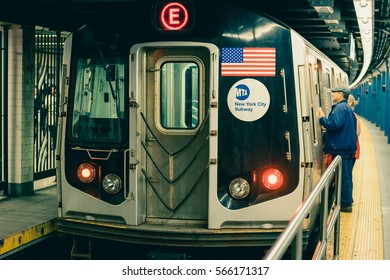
[0, 0, 390, 85]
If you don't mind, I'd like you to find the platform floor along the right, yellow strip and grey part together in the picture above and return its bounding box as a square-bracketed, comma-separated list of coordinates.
[339, 118, 390, 260]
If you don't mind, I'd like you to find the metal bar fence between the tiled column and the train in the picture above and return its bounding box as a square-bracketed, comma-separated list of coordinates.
[34, 30, 65, 179]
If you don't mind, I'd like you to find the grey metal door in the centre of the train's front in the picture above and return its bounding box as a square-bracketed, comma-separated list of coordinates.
[130, 43, 217, 220]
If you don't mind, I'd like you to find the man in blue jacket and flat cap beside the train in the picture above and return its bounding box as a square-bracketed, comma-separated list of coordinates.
[318, 86, 357, 212]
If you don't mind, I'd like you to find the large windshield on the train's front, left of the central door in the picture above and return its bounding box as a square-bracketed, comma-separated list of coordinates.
[71, 57, 126, 142]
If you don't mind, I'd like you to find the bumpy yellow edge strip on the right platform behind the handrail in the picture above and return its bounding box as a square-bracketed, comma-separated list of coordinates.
[340, 118, 384, 260]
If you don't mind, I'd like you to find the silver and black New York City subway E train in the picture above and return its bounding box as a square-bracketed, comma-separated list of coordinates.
[57, 0, 348, 258]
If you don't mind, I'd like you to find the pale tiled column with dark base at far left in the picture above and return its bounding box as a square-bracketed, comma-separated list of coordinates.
[8, 26, 35, 196]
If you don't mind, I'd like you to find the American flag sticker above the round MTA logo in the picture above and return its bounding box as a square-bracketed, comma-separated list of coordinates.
[221, 48, 276, 76]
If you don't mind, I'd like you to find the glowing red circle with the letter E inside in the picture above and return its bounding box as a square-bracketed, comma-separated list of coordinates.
[160, 2, 188, 30]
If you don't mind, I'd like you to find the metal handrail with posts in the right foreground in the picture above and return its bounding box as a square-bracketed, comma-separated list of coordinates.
[263, 156, 342, 260]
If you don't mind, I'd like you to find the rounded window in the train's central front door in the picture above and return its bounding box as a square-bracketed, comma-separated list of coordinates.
[157, 61, 202, 133]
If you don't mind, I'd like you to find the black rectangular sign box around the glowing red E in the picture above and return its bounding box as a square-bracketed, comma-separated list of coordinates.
[154, 1, 195, 33]
